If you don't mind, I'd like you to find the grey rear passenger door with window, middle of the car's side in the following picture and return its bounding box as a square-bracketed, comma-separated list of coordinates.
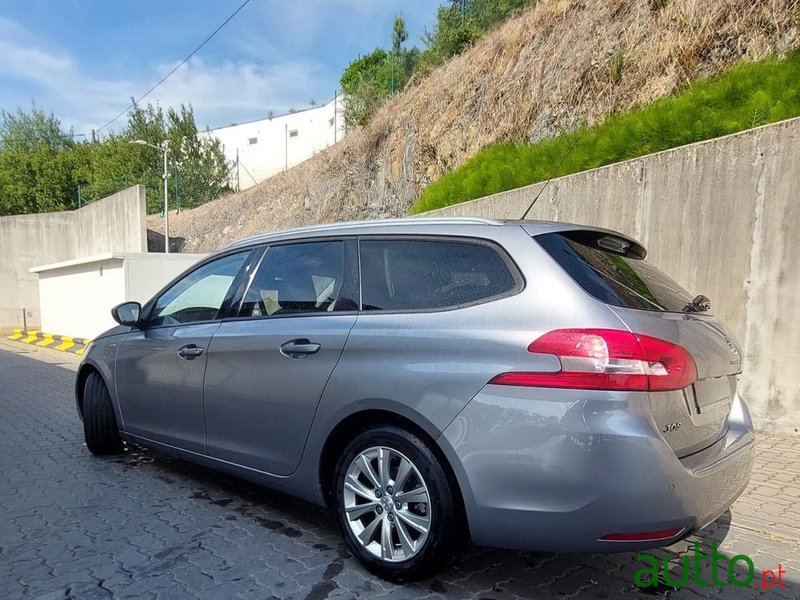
[204, 240, 358, 475]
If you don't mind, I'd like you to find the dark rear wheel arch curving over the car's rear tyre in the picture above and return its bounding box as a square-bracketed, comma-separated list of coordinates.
[318, 409, 469, 532]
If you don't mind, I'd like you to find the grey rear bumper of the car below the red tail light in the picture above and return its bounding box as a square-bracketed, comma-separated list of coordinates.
[440, 386, 755, 552]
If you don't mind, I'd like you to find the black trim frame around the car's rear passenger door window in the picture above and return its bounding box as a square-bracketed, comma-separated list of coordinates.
[222, 236, 361, 323]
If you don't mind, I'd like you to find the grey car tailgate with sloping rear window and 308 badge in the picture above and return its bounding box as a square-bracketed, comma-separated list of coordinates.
[535, 231, 742, 456]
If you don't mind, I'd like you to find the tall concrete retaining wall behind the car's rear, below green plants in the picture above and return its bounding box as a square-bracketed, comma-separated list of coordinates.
[427, 119, 800, 432]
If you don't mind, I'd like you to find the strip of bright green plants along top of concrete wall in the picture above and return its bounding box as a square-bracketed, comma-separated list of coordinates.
[412, 53, 800, 213]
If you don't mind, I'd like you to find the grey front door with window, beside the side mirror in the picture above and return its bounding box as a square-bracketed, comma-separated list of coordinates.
[116, 250, 252, 453]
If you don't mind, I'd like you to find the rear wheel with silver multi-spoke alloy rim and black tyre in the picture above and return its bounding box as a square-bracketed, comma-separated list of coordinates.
[334, 426, 460, 582]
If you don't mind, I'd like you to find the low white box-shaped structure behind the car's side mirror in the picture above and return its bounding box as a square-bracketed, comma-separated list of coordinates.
[33, 253, 204, 339]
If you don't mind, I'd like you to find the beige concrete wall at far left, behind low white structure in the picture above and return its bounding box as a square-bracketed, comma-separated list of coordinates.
[0, 186, 147, 332]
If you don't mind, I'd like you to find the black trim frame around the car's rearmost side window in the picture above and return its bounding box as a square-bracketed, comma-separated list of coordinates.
[358, 233, 527, 315]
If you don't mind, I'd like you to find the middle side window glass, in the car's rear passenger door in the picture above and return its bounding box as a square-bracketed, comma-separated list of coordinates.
[239, 241, 357, 317]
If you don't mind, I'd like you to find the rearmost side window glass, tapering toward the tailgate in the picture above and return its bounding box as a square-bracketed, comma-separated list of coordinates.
[360, 239, 517, 311]
